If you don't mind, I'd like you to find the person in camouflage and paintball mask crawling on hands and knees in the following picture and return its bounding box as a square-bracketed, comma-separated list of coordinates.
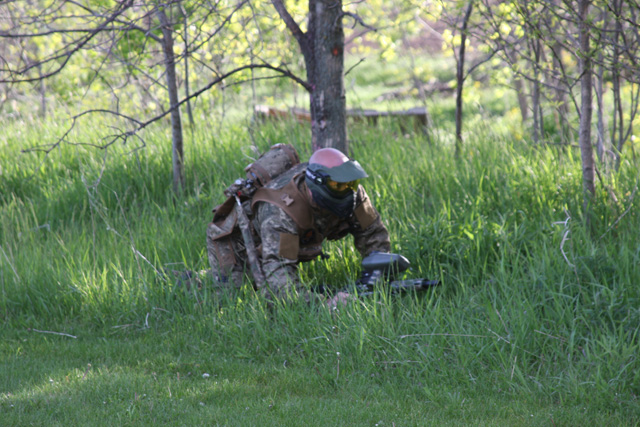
[207, 144, 391, 307]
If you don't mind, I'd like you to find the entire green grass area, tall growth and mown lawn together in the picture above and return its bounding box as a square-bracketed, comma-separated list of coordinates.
[0, 108, 640, 426]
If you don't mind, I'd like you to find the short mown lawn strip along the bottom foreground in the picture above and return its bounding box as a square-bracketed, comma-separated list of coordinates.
[0, 322, 630, 426]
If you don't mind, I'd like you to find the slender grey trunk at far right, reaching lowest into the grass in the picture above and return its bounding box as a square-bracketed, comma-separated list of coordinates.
[578, 0, 596, 207]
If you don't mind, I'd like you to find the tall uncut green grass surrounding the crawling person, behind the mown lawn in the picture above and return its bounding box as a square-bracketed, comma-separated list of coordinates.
[0, 110, 640, 417]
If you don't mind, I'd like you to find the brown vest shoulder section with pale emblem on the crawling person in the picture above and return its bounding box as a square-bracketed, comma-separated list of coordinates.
[251, 178, 313, 230]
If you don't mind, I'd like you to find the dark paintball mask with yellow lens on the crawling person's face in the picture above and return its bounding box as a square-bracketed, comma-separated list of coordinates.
[305, 160, 368, 218]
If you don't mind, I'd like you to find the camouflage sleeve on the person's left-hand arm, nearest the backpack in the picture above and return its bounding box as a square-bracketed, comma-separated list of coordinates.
[256, 202, 317, 302]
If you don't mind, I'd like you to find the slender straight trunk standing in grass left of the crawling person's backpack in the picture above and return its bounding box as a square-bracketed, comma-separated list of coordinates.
[156, 8, 184, 193]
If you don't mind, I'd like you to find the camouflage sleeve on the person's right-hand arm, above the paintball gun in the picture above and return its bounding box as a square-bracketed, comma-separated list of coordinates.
[351, 186, 391, 257]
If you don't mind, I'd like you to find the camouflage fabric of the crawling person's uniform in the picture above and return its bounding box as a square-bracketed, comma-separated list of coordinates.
[207, 164, 391, 301]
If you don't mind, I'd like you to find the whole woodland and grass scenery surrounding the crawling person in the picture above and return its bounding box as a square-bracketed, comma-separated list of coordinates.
[0, 0, 640, 425]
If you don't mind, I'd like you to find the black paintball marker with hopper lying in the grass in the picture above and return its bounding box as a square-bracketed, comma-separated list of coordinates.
[352, 252, 440, 296]
